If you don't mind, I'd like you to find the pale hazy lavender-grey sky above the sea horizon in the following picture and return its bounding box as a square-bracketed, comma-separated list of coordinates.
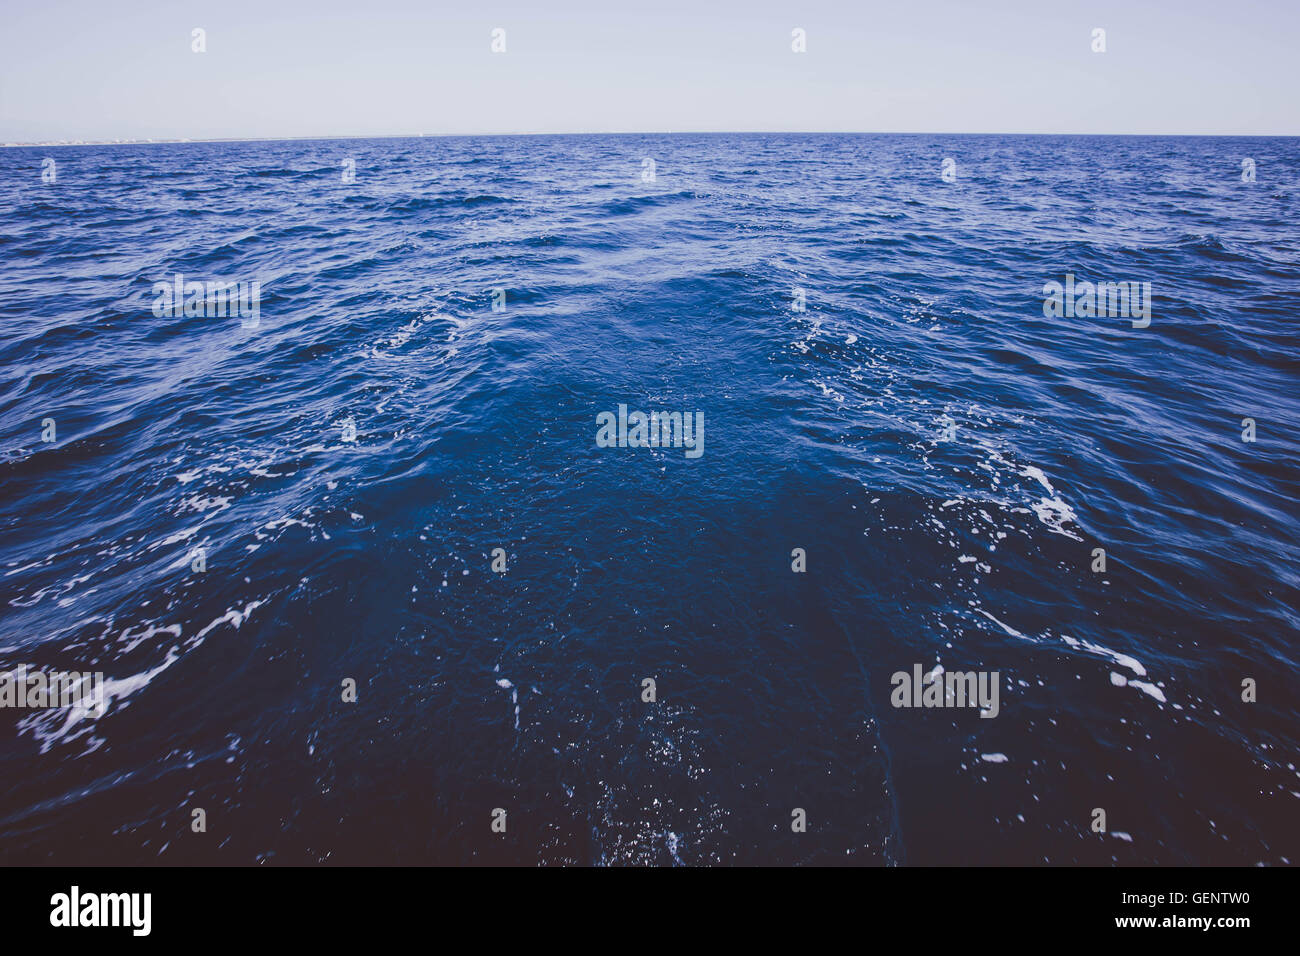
[0, 0, 1300, 142]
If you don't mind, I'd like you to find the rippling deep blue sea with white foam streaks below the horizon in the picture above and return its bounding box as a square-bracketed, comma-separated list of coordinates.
[0, 135, 1300, 865]
